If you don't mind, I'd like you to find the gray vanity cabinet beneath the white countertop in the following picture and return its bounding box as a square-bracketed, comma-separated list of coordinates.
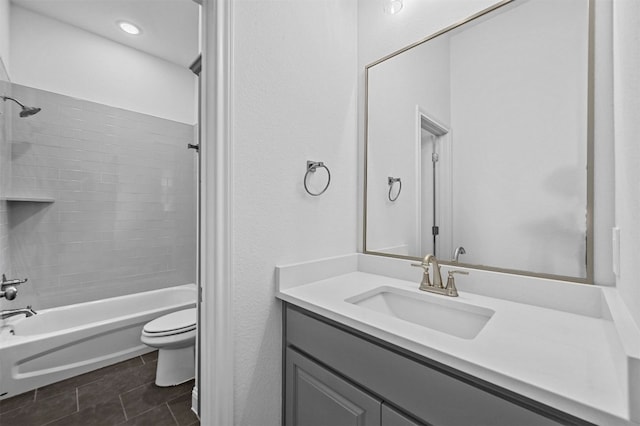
[283, 303, 590, 426]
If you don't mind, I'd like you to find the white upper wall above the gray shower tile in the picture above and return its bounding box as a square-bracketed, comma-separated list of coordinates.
[10, 5, 196, 124]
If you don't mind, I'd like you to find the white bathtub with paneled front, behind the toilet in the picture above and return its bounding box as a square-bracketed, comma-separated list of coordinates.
[0, 284, 197, 399]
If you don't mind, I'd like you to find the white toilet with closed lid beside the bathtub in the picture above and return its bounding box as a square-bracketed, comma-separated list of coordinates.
[140, 308, 196, 387]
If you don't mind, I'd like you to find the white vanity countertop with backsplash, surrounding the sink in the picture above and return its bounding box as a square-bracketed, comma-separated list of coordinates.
[276, 254, 640, 426]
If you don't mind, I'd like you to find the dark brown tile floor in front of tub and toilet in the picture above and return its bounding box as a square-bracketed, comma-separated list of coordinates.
[0, 352, 200, 426]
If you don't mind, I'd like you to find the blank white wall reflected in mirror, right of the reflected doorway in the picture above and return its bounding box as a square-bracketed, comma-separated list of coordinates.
[451, 0, 588, 278]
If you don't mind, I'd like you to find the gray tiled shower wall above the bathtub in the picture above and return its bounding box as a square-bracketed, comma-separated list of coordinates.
[8, 85, 196, 309]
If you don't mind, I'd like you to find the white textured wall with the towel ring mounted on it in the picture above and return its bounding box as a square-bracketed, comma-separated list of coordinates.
[230, 0, 358, 426]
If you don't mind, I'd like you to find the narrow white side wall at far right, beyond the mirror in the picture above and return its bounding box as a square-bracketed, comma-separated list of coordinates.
[613, 0, 640, 326]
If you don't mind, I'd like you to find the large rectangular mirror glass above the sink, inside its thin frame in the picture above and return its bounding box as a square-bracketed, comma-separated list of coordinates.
[364, 0, 593, 282]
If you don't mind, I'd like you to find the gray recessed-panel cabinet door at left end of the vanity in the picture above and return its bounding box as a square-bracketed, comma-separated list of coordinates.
[285, 348, 381, 426]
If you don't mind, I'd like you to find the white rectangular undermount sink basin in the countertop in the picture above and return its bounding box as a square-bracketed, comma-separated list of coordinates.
[346, 287, 495, 339]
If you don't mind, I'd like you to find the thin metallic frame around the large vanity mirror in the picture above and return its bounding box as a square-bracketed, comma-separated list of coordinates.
[362, 0, 595, 284]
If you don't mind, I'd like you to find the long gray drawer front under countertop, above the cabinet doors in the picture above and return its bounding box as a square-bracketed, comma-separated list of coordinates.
[285, 306, 589, 426]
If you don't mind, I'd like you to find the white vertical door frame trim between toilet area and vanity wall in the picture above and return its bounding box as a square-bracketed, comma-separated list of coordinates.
[198, 0, 235, 425]
